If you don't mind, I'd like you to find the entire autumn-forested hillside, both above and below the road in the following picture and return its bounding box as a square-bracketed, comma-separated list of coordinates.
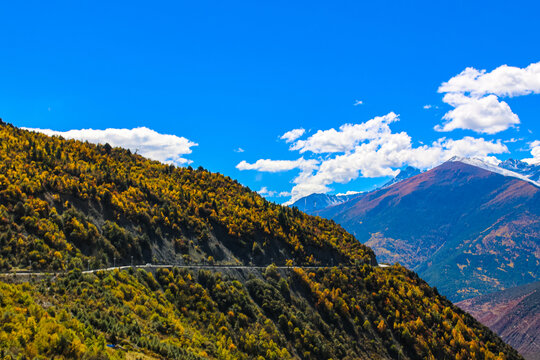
[0, 125, 520, 359]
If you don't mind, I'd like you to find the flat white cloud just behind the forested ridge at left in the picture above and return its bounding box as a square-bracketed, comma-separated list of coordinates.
[27, 127, 198, 165]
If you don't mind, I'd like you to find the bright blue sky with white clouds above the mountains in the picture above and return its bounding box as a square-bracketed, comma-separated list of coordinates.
[0, 1, 540, 202]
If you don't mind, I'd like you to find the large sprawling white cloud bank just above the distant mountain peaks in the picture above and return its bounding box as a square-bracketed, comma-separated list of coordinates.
[237, 113, 508, 204]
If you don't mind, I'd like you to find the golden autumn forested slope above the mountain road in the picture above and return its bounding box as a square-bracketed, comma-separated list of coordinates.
[0, 121, 374, 270]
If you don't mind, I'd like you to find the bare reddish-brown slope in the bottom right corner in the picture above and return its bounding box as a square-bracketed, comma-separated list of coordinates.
[456, 282, 540, 360]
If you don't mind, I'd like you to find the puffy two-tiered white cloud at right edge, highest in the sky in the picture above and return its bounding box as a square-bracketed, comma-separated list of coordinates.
[435, 62, 540, 134]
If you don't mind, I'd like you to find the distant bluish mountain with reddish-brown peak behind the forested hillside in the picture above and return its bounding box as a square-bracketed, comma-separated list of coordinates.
[317, 161, 540, 300]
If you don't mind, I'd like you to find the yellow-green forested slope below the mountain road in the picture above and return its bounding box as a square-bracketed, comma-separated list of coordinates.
[0, 265, 521, 360]
